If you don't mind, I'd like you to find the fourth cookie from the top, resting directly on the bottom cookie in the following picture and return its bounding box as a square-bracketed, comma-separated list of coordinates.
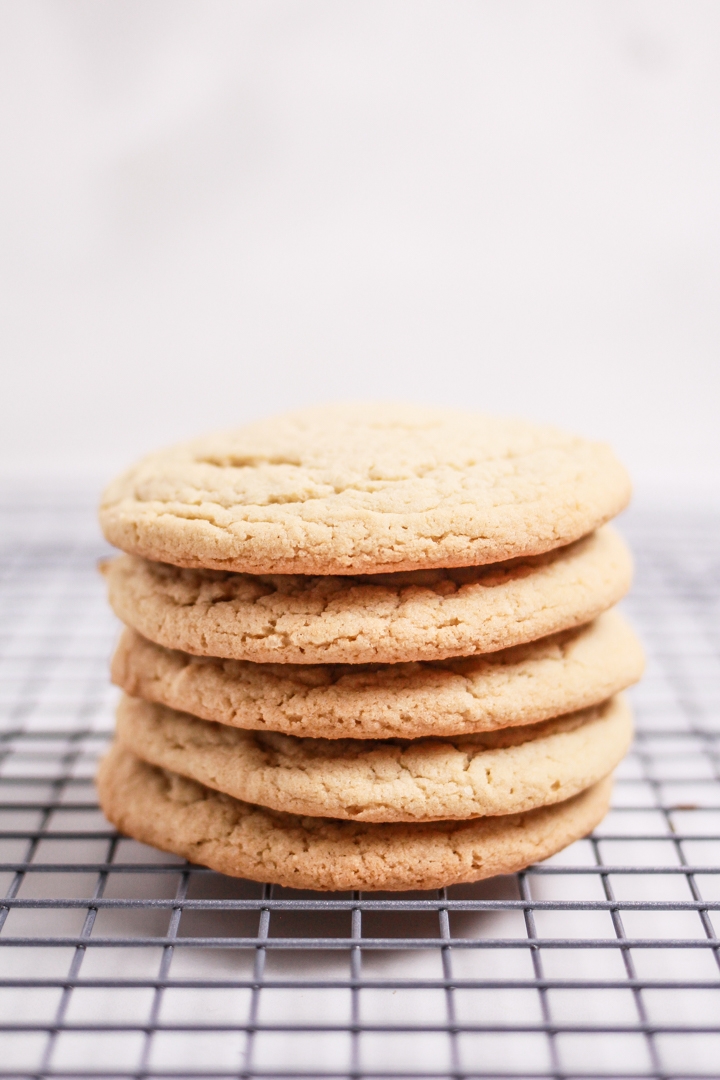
[117, 697, 633, 822]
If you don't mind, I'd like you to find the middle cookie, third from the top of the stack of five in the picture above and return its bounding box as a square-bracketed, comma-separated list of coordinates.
[112, 610, 643, 739]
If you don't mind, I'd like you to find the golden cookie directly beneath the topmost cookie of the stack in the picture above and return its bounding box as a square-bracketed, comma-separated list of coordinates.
[105, 526, 631, 664]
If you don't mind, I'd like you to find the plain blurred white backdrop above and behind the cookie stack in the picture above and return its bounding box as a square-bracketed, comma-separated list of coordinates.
[0, 0, 720, 492]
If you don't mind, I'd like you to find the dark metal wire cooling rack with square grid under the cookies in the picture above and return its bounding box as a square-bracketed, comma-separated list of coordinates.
[0, 487, 720, 1080]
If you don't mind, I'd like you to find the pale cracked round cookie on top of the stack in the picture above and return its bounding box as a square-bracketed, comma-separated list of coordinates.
[100, 405, 630, 575]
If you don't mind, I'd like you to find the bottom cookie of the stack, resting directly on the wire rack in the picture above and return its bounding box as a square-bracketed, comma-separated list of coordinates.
[97, 743, 611, 890]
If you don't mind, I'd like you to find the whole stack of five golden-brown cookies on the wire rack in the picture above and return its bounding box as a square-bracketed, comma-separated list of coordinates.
[97, 405, 642, 890]
